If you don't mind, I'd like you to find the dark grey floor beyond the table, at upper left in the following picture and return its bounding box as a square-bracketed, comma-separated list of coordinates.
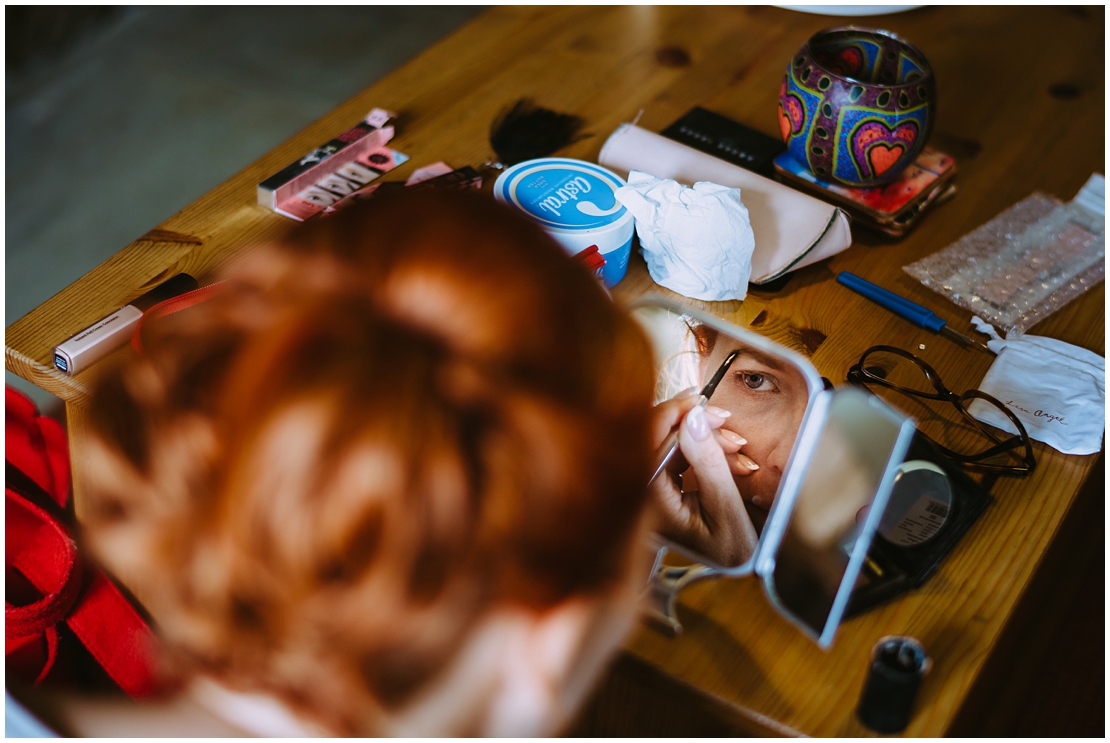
[4, 6, 482, 408]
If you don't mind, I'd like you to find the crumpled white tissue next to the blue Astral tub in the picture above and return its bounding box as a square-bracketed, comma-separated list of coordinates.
[616, 170, 756, 301]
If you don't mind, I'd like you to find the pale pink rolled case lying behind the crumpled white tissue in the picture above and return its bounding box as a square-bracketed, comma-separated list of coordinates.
[598, 124, 851, 284]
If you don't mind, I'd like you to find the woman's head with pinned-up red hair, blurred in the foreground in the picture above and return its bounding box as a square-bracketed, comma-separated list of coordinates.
[85, 192, 653, 735]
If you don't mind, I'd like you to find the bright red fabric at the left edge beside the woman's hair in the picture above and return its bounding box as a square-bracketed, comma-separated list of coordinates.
[4, 388, 155, 696]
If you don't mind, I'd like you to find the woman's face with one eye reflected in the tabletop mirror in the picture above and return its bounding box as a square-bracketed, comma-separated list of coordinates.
[699, 337, 809, 509]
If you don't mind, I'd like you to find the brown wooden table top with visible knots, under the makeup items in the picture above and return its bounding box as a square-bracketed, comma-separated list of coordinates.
[6, 7, 1104, 735]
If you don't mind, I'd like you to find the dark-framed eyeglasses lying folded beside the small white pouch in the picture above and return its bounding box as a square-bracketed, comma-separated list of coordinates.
[848, 345, 1037, 474]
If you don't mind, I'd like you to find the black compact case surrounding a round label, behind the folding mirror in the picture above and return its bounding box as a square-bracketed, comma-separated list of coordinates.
[845, 432, 993, 616]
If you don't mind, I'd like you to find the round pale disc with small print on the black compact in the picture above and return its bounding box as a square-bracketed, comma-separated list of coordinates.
[879, 460, 952, 546]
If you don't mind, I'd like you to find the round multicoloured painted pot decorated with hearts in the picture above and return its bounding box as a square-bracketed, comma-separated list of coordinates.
[778, 28, 937, 187]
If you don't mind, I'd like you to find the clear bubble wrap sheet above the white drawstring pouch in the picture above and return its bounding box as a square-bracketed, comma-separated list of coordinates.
[904, 193, 1106, 335]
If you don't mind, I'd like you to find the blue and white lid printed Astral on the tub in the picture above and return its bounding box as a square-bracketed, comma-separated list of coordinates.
[493, 158, 632, 231]
